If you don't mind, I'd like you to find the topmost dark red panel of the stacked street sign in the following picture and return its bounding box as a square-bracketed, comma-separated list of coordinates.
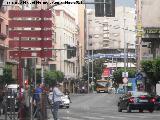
[9, 10, 52, 18]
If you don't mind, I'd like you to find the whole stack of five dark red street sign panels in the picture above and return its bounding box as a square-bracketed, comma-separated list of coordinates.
[9, 10, 52, 58]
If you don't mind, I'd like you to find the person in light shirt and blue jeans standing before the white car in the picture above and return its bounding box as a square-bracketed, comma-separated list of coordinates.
[52, 83, 64, 120]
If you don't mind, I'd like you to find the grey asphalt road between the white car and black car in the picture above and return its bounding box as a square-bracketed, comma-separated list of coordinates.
[47, 93, 160, 120]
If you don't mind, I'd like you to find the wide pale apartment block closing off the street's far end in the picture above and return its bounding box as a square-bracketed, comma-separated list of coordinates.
[87, 6, 136, 69]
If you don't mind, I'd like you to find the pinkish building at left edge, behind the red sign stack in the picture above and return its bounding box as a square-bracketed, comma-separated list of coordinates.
[0, 2, 21, 84]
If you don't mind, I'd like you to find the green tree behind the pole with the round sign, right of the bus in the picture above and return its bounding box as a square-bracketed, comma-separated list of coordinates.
[113, 68, 136, 84]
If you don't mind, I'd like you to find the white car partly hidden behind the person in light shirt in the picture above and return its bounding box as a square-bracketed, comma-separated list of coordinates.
[48, 92, 70, 108]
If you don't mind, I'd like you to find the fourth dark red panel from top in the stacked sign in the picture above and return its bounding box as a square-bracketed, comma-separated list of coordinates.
[9, 40, 52, 48]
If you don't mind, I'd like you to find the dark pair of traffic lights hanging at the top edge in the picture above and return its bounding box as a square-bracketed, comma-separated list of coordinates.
[94, 0, 115, 17]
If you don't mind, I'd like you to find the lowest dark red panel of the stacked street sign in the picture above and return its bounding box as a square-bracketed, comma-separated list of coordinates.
[9, 50, 52, 58]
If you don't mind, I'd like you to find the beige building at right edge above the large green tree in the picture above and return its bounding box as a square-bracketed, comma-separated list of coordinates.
[136, 0, 160, 69]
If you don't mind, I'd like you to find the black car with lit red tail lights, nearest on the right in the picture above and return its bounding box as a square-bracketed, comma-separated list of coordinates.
[118, 92, 155, 113]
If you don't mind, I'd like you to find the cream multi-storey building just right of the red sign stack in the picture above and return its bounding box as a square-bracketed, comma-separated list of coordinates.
[54, 8, 77, 92]
